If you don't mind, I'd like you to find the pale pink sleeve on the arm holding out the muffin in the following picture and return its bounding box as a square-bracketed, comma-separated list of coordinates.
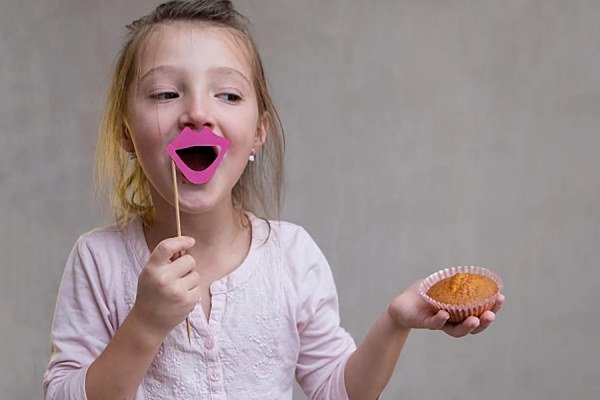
[296, 228, 356, 400]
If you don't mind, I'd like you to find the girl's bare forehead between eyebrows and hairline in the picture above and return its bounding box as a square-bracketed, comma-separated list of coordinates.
[137, 22, 252, 80]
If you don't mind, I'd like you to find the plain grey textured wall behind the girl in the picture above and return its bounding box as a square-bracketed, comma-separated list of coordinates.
[0, 0, 600, 400]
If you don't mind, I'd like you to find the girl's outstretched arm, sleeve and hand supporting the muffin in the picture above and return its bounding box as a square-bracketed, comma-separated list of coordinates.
[296, 228, 504, 400]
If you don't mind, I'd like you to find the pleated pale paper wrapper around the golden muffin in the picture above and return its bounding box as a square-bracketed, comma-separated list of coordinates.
[419, 266, 503, 322]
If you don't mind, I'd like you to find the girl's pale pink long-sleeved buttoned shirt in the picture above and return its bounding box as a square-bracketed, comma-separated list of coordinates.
[44, 216, 356, 400]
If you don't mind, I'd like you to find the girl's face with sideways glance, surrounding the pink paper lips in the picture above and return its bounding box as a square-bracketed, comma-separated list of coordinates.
[124, 23, 266, 213]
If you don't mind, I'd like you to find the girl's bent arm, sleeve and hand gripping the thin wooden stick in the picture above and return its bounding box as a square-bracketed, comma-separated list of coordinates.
[44, 238, 200, 400]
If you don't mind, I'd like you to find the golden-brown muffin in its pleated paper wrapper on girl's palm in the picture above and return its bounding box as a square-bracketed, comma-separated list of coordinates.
[419, 266, 503, 322]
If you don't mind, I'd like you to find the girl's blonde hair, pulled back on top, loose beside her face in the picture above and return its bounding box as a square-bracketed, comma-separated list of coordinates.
[96, 0, 285, 225]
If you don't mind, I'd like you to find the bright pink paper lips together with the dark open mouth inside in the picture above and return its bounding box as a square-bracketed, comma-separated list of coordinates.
[167, 127, 229, 185]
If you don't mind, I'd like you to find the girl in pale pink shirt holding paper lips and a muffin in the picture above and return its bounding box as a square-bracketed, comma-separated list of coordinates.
[44, 0, 503, 400]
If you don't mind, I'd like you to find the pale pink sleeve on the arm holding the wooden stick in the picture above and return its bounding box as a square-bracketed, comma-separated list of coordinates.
[43, 238, 114, 400]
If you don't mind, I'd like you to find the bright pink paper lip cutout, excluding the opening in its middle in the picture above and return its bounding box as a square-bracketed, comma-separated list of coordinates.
[167, 127, 229, 185]
